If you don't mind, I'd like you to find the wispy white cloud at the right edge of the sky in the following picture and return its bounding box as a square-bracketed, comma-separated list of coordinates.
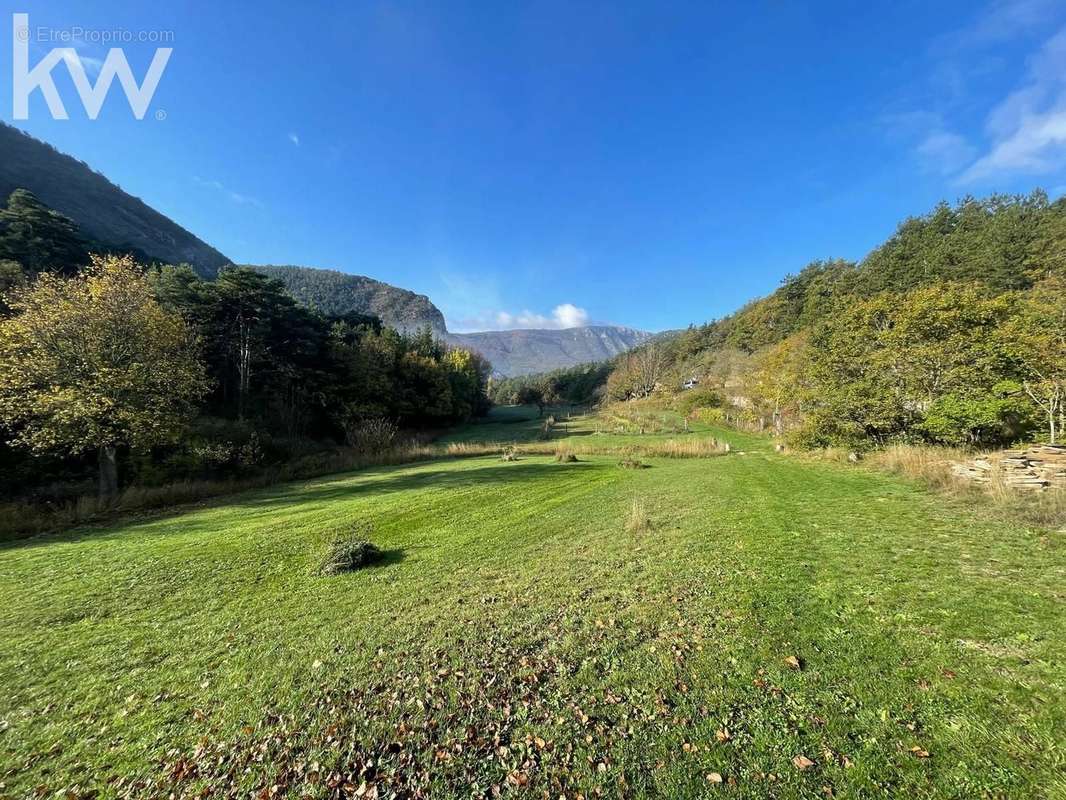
[959, 27, 1066, 183]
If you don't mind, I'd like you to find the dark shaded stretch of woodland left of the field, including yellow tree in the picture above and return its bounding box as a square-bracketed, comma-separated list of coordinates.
[0, 251, 489, 514]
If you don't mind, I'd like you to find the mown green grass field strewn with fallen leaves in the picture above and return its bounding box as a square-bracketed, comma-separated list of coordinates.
[0, 410, 1066, 798]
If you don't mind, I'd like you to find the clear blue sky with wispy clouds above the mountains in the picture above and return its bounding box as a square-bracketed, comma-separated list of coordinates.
[0, 0, 1066, 330]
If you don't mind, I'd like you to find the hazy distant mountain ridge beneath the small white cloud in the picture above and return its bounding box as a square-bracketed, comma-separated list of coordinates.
[448, 325, 650, 377]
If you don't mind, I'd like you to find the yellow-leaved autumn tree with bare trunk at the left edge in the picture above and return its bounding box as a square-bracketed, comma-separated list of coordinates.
[0, 256, 207, 501]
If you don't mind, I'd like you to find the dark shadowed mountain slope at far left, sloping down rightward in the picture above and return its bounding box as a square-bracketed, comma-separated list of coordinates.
[0, 123, 229, 277]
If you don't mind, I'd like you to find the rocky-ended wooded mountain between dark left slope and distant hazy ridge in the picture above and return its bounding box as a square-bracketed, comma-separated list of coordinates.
[247, 265, 448, 336]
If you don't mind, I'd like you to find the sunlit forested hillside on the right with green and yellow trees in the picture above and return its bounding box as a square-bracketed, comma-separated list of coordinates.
[607, 191, 1066, 446]
